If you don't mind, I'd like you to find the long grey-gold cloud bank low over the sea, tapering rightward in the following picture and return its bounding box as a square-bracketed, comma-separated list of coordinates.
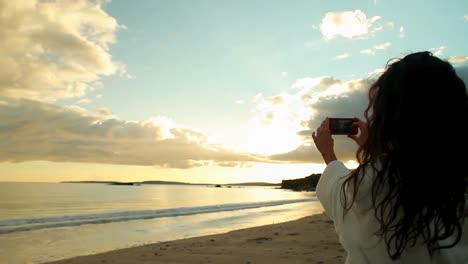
[0, 97, 262, 168]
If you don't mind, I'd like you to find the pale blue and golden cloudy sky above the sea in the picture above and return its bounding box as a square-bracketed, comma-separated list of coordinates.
[0, 0, 468, 183]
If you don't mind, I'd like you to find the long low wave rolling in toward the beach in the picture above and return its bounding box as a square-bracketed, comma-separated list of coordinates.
[0, 197, 317, 234]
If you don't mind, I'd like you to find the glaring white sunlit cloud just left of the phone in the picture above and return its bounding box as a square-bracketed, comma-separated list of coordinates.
[238, 82, 336, 155]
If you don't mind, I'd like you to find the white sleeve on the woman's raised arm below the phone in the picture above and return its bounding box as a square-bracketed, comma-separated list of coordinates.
[315, 160, 350, 231]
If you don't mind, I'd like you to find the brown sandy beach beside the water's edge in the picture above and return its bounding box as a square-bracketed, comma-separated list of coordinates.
[44, 213, 346, 264]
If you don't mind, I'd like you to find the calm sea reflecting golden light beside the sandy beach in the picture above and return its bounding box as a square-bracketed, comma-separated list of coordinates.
[0, 183, 322, 264]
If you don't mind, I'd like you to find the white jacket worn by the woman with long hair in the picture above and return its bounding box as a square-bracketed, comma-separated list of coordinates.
[316, 160, 468, 264]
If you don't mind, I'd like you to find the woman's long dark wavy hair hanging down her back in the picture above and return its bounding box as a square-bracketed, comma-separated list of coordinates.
[341, 51, 468, 260]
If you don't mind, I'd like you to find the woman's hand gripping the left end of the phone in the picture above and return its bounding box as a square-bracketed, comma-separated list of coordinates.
[312, 117, 336, 164]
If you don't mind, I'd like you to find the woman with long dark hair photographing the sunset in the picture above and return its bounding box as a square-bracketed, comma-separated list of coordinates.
[312, 52, 468, 263]
